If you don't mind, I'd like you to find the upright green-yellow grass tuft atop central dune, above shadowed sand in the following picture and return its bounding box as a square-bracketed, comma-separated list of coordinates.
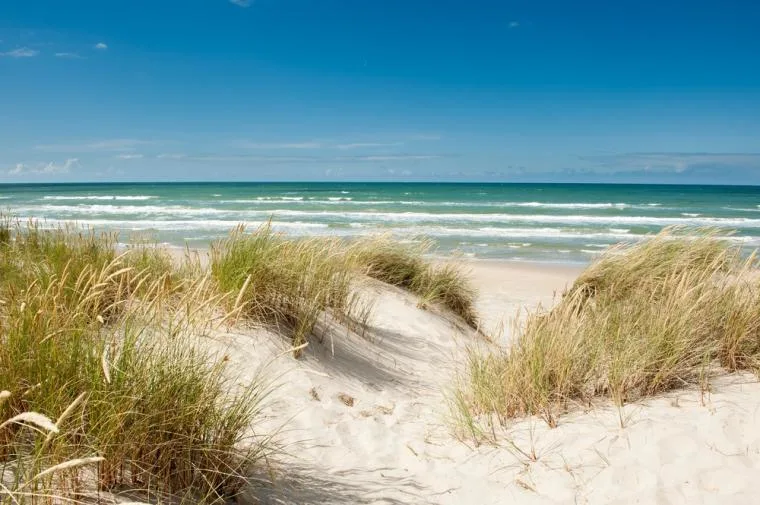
[211, 225, 353, 354]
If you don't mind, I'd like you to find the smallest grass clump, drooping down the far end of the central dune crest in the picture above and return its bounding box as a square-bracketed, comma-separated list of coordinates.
[352, 236, 478, 328]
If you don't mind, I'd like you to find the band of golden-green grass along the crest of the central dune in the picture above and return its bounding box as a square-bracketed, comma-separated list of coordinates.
[211, 225, 477, 355]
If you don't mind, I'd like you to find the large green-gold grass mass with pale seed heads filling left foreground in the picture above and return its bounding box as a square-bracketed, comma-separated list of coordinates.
[0, 223, 272, 503]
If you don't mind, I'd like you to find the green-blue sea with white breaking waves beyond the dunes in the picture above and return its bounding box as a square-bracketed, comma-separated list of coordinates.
[0, 182, 760, 263]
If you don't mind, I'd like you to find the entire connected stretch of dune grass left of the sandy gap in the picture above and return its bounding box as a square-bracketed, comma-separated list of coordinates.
[0, 220, 475, 503]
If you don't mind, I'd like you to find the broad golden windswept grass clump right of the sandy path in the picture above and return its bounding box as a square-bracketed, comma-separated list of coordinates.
[458, 226, 760, 428]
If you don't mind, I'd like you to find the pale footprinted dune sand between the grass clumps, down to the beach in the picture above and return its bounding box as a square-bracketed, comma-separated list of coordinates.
[209, 263, 760, 504]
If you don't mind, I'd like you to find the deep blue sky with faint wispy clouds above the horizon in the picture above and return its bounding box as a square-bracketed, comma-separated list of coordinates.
[0, 0, 760, 184]
